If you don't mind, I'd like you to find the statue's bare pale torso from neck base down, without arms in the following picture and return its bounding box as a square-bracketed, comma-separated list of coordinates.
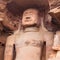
[15, 29, 43, 60]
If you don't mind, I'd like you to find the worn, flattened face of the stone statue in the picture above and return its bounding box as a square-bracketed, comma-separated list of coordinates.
[22, 9, 38, 26]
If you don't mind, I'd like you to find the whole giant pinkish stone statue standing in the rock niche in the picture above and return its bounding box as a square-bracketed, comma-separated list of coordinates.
[4, 8, 54, 60]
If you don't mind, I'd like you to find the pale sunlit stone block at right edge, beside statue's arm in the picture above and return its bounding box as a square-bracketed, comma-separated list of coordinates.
[52, 31, 60, 51]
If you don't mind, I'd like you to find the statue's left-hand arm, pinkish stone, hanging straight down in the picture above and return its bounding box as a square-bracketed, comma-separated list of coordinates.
[4, 36, 14, 60]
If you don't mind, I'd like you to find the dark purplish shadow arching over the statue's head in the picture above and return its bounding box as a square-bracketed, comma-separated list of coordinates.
[6, 1, 46, 16]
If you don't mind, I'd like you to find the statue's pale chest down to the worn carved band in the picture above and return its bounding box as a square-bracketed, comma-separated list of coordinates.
[15, 32, 43, 47]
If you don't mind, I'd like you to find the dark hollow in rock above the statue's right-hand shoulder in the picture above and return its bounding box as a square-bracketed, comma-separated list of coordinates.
[44, 17, 60, 33]
